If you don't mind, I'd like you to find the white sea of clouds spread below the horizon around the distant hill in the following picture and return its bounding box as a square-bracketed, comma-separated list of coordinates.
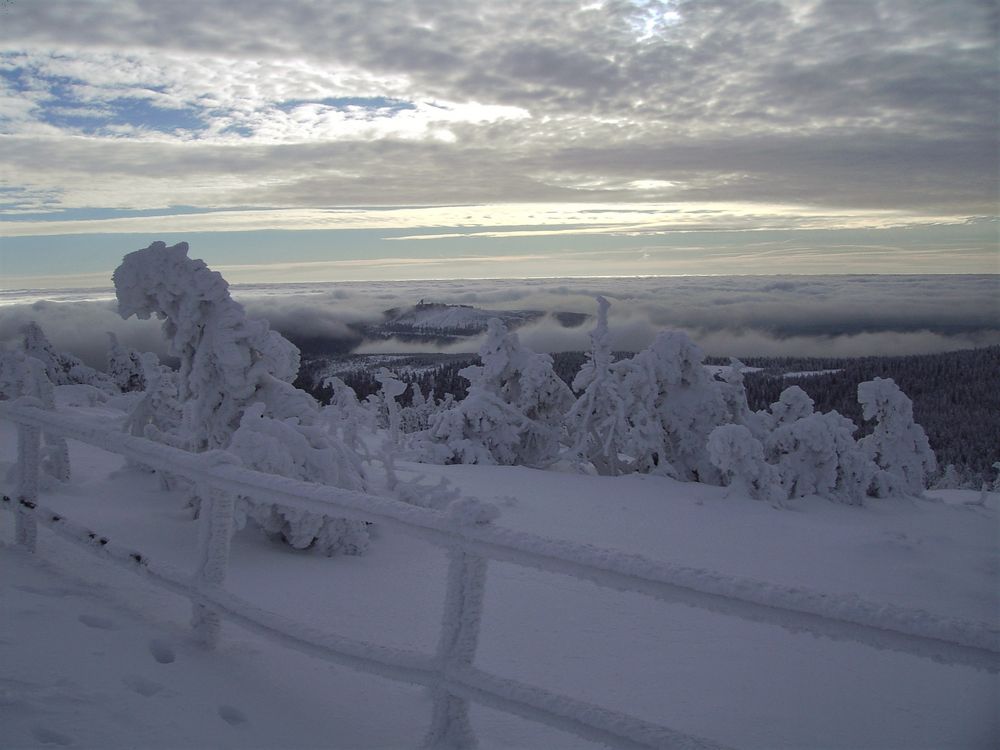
[0, 275, 1000, 366]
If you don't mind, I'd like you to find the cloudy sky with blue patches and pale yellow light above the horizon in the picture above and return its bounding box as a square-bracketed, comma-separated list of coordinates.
[0, 0, 1000, 289]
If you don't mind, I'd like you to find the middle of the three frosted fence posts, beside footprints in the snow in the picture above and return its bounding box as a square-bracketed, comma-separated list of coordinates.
[191, 486, 236, 648]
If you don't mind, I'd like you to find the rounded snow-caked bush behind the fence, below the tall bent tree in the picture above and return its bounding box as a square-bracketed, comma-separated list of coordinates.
[229, 403, 369, 555]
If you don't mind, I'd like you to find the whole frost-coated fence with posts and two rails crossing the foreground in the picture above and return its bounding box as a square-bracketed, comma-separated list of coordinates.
[0, 406, 1000, 748]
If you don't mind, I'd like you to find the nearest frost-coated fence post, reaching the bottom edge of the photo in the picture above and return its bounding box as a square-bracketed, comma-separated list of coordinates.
[423, 499, 499, 750]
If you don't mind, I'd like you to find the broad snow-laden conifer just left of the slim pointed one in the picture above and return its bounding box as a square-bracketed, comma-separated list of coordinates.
[419, 318, 573, 466]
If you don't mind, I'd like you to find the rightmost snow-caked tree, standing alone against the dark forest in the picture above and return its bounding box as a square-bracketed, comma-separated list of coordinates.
[858, 378, 937, 497]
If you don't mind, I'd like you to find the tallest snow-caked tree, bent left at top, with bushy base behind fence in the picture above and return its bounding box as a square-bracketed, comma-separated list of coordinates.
[113, 242, 363, 551]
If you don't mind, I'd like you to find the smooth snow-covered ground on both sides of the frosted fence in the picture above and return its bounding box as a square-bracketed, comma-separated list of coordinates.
[0, 411, 1000, 748]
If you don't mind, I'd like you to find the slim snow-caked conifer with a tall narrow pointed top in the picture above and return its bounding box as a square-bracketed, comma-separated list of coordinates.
[566, 297, 630, 475]
